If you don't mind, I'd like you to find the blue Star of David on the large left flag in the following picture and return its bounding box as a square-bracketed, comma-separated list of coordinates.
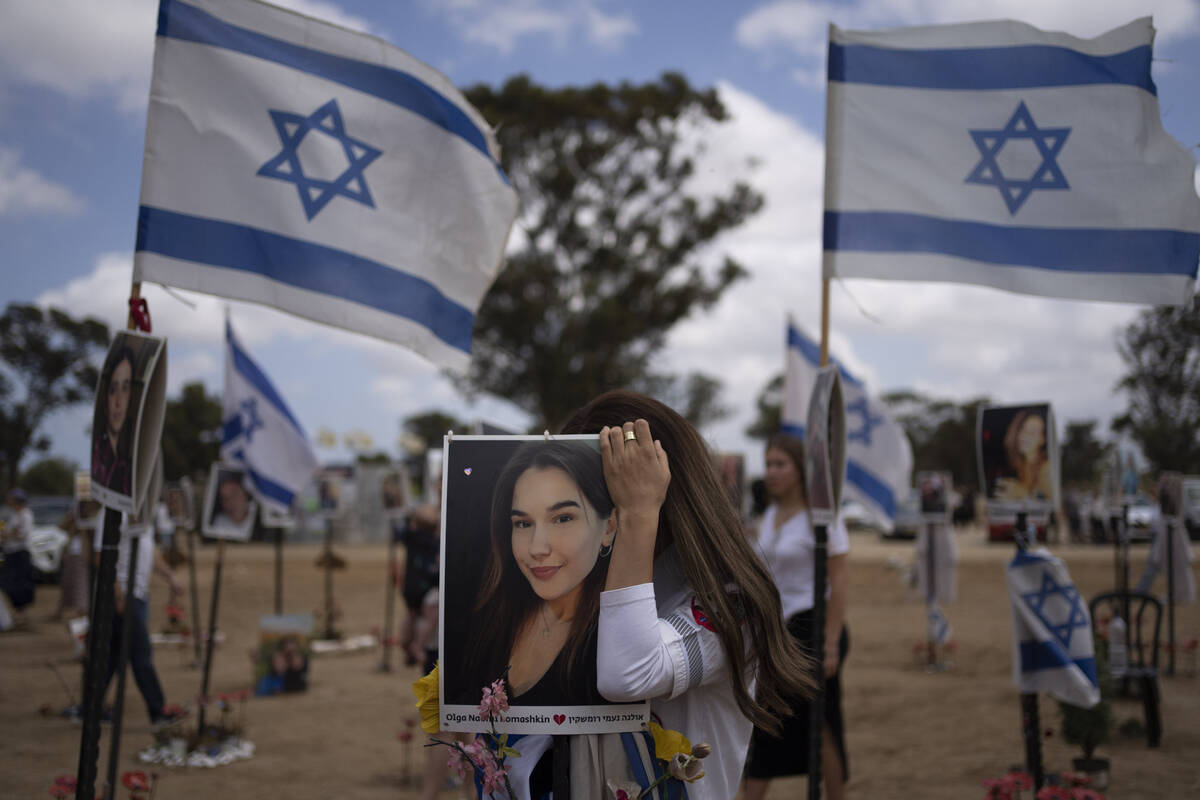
[257, 100, 383, 221]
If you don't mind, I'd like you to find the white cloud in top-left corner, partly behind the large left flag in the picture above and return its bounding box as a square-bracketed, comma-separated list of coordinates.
[0, 0, 368, 112]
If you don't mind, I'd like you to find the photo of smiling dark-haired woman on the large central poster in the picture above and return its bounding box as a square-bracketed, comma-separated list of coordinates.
[443, 438, 637, 730]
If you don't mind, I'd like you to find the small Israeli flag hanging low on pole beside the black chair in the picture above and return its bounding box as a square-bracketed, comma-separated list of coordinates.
[1008, 547, 1100, 708]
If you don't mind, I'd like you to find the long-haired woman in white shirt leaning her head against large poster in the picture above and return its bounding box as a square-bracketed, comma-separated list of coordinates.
[563, 391, 811, 800]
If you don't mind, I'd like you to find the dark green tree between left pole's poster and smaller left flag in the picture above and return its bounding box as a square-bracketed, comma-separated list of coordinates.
[162, 381, 222, 481]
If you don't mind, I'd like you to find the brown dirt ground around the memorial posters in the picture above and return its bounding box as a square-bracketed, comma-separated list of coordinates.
[0, 529, 1200, 800]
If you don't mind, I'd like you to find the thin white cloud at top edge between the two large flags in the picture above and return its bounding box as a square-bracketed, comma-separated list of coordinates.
[433, 0, 638, 55]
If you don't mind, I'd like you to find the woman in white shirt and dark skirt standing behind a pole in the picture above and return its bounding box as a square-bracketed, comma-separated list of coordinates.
[744, 435, 850, 800]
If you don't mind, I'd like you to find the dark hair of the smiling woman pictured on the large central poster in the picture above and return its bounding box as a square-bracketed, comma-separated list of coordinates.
[467, 441, 612, 692]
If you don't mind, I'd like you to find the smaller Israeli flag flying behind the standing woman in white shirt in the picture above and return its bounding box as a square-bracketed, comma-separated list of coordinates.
[782, 321, 912, 525]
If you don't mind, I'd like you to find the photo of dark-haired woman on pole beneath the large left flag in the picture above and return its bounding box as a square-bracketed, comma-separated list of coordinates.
[91, 344, 137, 495]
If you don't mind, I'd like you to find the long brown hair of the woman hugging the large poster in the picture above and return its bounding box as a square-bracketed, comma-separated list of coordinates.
[563, 390, 814, 733]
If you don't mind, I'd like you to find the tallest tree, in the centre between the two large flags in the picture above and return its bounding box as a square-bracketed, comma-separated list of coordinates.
[466, 73, 762, 429]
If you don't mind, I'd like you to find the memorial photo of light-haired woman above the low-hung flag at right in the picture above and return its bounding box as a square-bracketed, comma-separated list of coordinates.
[978, 403, 1058, 512]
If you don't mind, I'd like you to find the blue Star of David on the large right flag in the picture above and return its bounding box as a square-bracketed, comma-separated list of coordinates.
[966, 101, 1070, 216]
